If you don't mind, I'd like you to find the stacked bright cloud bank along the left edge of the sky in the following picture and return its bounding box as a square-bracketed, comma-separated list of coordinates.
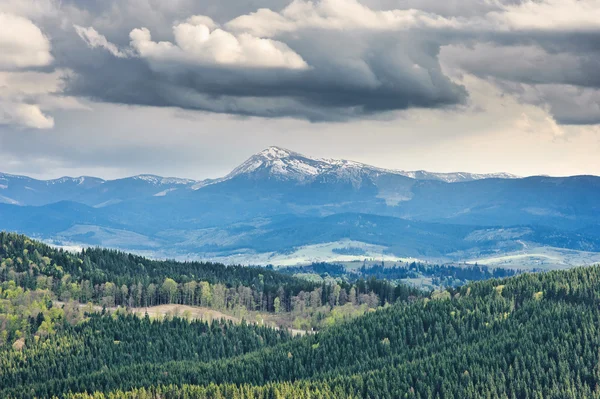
[0, 5, 84, 130]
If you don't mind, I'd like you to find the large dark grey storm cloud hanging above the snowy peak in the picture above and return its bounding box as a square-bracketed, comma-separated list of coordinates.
[56, 28, 467, 121]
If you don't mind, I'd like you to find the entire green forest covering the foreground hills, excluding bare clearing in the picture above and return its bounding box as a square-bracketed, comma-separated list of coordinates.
[0, 233, 600, 399]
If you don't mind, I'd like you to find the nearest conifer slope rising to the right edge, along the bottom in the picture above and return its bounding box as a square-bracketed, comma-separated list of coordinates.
[5, 267, 600, 399]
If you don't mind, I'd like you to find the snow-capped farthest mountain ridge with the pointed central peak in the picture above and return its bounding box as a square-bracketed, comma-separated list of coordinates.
[0, 147, 516, 207]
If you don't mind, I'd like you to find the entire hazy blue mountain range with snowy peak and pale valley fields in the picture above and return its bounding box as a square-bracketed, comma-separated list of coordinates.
[0, 147, 600, 267]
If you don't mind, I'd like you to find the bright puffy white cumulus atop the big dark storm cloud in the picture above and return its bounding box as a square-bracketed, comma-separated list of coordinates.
[130, 16, 308, 69]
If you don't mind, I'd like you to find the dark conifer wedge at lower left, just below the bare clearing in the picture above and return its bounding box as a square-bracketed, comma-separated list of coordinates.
[0, 313, 292, 396]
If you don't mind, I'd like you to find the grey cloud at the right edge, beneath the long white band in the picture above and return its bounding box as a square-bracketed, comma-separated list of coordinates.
[442, 40, 600, 125]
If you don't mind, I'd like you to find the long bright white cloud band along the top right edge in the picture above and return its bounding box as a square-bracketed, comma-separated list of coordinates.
[225, 0, 600, 37]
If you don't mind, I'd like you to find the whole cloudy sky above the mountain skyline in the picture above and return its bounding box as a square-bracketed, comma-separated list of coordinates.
[0, 0, 600, 179]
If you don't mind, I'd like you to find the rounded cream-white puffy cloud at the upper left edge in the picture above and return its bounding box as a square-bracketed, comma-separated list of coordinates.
[0, 12, 52, 70]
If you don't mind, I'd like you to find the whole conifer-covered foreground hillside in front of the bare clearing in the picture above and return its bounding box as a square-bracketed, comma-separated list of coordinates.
[0, 236, 600, 398]
